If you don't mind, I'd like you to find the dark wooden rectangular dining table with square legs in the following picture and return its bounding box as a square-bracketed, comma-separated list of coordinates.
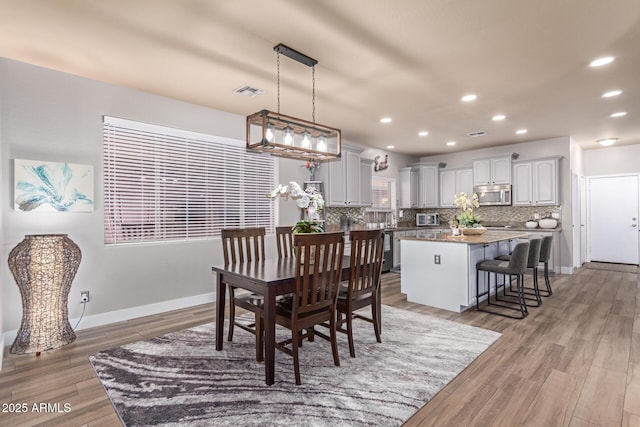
[212, 256, 370, 385]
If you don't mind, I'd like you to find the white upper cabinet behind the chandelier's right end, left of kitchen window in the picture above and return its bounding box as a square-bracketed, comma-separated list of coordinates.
[318, 147, 372, 207]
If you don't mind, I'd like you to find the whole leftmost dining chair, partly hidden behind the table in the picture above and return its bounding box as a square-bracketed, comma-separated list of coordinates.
[221, 227, 265, 362]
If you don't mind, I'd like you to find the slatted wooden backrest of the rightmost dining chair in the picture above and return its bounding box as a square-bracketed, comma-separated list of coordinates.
[347, 230, 384, 298]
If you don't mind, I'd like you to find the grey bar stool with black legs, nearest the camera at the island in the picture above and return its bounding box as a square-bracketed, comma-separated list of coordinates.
[476, 241, 529, 319]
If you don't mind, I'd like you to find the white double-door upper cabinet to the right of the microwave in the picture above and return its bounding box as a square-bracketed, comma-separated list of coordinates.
[513, 157, 559, 206]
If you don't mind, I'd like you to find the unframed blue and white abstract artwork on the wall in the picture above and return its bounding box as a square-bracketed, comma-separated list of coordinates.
[14, 159, 94, 212]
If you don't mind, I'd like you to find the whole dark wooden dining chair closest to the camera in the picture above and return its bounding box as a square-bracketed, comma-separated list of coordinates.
[276, 232, 344, 385]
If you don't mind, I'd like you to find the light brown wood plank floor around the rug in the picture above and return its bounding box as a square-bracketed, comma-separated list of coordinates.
[0, 268, 640, 427]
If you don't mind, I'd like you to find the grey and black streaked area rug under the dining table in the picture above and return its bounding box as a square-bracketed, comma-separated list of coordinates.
[89, 306, 500, 427]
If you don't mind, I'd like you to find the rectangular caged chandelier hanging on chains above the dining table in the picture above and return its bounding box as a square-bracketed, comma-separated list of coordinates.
[247, 43, 341, 161]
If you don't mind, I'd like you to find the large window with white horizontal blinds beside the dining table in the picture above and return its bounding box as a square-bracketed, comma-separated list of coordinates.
[103, 116, 277, 244]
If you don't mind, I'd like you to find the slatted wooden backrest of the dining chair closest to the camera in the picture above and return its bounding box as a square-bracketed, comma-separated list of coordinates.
[292, 232, 344, 317]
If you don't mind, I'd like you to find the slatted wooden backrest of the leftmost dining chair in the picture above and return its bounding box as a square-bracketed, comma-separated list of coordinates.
[222, 227, 265, 264]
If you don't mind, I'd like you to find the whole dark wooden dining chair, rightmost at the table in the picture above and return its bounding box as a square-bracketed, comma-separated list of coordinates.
[336, 230, 384, 357]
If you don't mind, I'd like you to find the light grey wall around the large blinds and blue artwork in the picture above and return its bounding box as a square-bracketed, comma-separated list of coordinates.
[0, 58, 308, 344]
